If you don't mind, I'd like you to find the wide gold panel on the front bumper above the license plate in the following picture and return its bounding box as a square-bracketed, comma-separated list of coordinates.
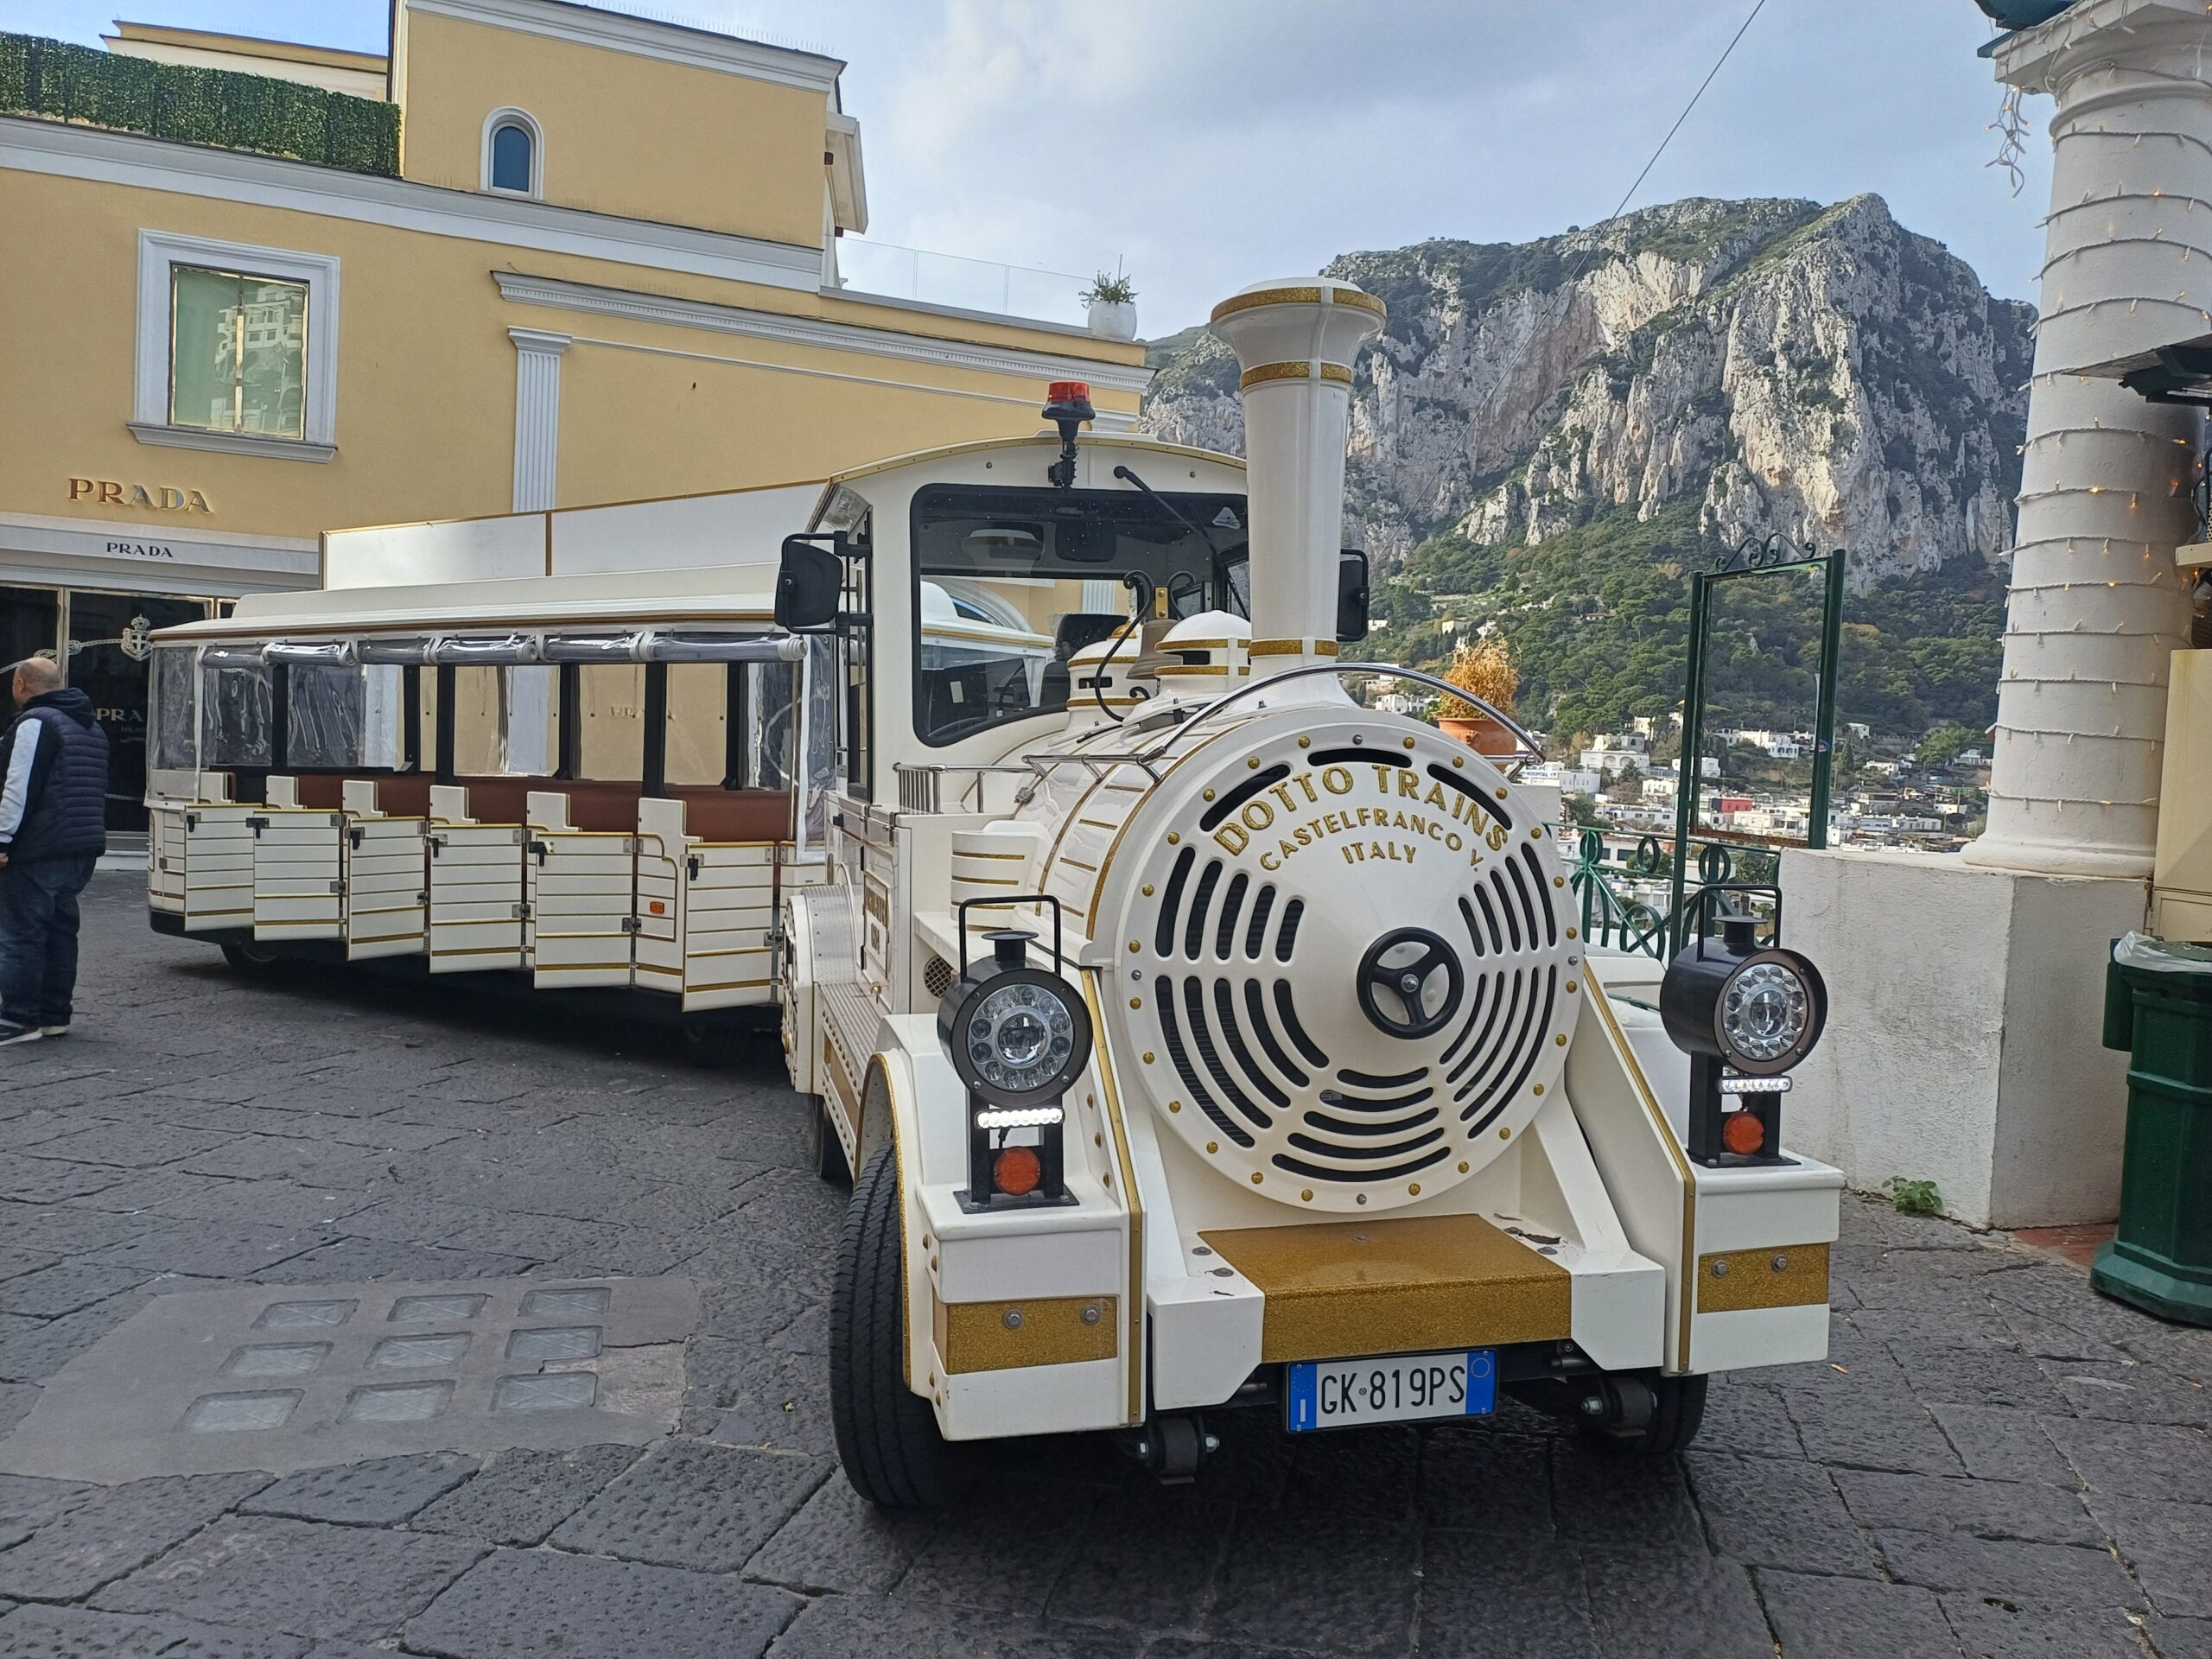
[1199, 1214, 1575, 1365]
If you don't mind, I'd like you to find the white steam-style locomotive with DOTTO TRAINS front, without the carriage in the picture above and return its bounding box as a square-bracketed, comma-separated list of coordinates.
[779, 281, 1840, 1506]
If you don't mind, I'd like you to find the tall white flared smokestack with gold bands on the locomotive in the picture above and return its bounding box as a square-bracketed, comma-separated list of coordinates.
[1212, 276, 1387, 675]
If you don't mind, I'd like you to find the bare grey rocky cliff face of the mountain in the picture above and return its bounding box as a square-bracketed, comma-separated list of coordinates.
[1144, 194, 2033, 591]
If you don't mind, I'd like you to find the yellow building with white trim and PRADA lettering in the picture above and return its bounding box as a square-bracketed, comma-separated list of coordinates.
[0, 0, 1146, 823]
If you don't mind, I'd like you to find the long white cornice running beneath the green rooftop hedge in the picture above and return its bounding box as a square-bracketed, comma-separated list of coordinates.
[0, 115, 823, 292]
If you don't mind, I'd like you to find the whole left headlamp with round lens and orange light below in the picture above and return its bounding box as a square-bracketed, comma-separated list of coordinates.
[938, 929, 1090, 1208]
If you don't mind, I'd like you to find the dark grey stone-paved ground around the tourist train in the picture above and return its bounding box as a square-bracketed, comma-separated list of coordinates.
[0, 874, 2212, 1659]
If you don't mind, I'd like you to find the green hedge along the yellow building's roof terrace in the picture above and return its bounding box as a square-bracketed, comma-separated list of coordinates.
[0, 33, 400, 177]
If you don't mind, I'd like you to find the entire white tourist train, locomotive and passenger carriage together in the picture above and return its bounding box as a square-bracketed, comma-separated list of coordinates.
[133, 279, 1842, 1506]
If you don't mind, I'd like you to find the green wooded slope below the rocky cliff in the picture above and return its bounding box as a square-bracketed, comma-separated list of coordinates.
[1371, 500, 2004, 736]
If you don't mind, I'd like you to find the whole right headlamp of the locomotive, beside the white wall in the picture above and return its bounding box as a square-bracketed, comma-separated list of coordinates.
[1659, 916, 1827, 1166]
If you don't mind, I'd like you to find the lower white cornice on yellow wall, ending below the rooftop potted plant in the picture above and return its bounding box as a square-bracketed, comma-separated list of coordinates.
[491, 270, 1153, 391]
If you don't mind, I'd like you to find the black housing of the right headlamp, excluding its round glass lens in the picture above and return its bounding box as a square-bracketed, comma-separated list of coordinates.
[1659, 889, 1827, 1168]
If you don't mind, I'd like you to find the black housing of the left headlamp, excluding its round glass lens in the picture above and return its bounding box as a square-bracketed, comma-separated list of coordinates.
[938, 893, 1090, 1210]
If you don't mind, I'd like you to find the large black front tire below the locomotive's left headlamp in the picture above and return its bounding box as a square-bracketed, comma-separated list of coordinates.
[830, 1146, 960, 1509]
